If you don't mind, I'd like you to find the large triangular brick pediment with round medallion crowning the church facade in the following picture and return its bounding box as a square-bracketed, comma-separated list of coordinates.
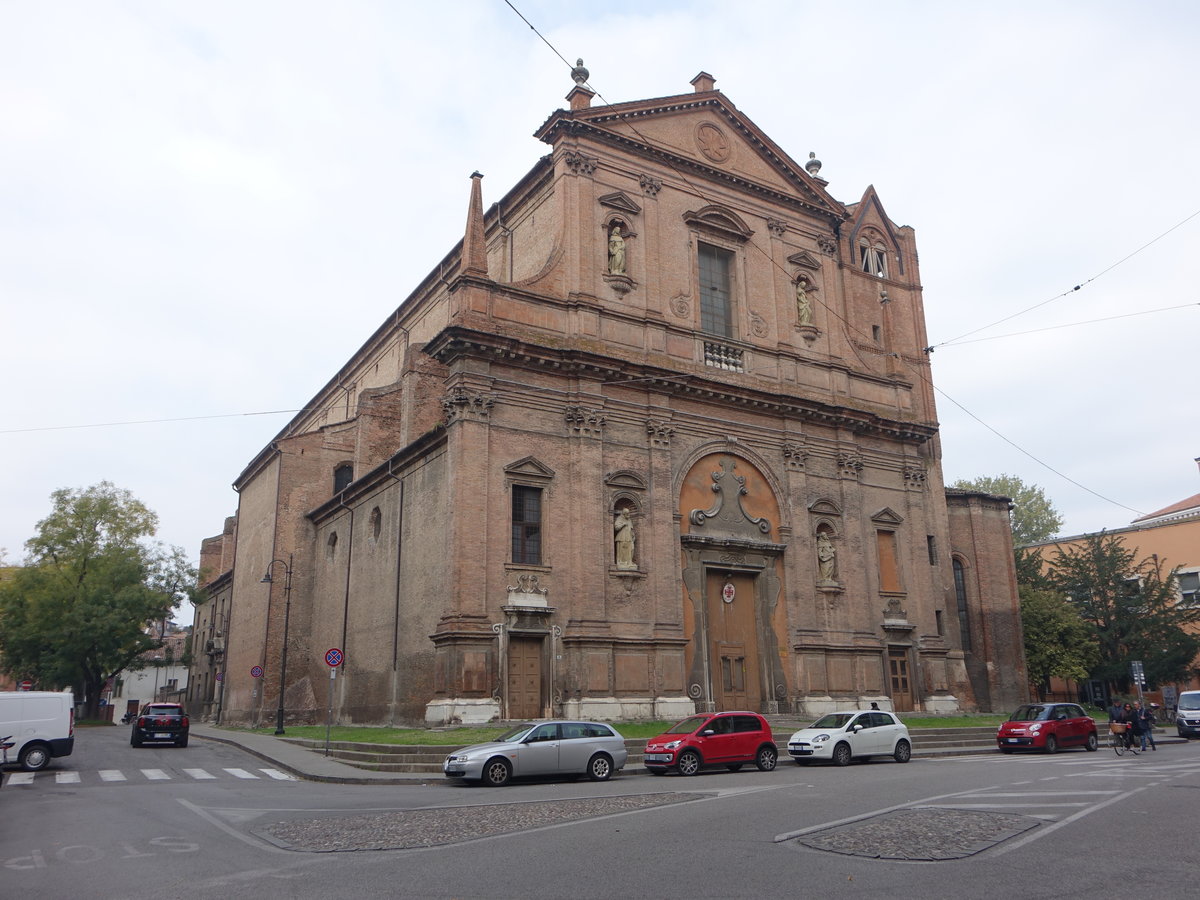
[536, 90, 846, 221]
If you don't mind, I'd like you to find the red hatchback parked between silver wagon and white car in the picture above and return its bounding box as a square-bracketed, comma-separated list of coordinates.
[642, 712, 779, 775]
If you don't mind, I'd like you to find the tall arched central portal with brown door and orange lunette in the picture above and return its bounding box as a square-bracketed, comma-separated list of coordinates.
[679, 452, 788, 713]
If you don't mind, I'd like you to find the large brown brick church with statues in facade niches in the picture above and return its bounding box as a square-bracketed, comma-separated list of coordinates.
[190, 73, 1027, 724]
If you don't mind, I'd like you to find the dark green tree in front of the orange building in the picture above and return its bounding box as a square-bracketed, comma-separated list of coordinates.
[1046, 532, 1200, 692]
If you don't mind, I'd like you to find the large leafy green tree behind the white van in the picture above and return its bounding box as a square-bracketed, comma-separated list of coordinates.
[0, 481, 196, 718]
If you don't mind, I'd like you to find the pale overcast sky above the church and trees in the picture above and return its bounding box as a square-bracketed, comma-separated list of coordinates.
[0, 0, 1200, 619]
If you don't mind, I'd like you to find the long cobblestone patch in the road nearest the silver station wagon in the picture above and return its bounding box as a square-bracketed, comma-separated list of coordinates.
[254, 793, 713, 853]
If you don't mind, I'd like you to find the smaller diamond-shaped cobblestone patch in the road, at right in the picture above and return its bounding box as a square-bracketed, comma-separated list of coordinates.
[797, 808, 1039, 862]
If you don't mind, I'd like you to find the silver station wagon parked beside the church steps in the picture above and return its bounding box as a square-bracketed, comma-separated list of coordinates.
[442, 719, 628, 787]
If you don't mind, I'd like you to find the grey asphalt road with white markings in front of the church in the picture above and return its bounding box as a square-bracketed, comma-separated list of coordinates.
[0, 728, 1200, 900]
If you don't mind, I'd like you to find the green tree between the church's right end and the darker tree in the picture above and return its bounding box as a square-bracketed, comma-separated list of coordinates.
[1021, 587, 1099, 700]
